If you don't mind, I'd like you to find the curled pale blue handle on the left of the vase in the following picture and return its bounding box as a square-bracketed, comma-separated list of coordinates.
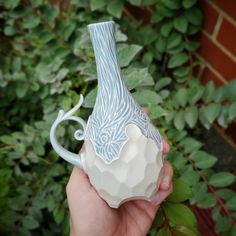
[50, 95, 86, 169]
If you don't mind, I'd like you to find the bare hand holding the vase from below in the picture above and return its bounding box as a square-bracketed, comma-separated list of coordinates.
[66, 143, 173, 236]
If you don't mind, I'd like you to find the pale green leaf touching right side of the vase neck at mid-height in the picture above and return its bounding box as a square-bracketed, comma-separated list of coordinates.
[118, 44, 142, 67]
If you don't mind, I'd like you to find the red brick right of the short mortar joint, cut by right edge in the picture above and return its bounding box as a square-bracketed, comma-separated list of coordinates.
[217, 19, 236, 56]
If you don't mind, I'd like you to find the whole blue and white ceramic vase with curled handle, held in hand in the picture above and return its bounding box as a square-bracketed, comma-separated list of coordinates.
[50, 22, 163, 208]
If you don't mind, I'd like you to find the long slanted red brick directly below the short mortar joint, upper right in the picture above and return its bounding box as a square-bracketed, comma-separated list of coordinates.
[198, 33, 236, 81]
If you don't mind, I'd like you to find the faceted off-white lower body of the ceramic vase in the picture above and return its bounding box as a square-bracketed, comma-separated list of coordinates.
[80, 124, 163, 208]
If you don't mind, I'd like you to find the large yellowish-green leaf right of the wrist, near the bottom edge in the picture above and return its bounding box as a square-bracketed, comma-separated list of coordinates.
[163, 202, 197, 227]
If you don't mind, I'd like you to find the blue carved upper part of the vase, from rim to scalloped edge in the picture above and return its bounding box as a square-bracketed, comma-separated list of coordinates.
[85, 22, 162, 163]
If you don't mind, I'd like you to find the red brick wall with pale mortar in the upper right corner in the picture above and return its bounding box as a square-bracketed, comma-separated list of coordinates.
[197, 0, 236, 86]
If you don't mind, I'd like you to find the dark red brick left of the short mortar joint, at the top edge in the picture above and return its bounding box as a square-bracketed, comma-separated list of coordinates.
[200, 0, 219, 34]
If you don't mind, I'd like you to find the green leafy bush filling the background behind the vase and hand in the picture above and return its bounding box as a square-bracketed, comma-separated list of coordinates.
[0, 0, 236, 236]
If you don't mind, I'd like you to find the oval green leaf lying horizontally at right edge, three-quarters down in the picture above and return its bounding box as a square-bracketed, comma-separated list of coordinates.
[209, 172, 235, 187]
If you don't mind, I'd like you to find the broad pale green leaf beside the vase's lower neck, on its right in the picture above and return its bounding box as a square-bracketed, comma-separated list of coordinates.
[123, 68, 154, 90]
